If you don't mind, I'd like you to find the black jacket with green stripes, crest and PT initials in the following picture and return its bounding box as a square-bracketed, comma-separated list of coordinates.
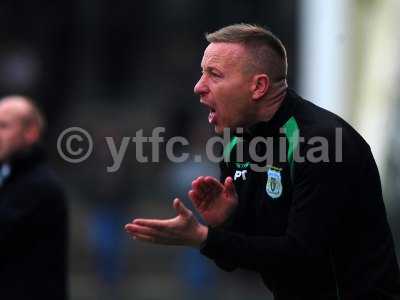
[201, 90, 400, 300]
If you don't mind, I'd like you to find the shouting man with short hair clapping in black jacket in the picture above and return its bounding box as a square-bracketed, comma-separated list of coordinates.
[125, 24, 400, 300]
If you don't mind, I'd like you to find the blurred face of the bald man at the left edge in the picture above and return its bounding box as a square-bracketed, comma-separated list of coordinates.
[0, 104, 26, 162]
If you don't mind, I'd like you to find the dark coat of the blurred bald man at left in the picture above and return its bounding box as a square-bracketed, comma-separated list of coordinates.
[0, 147, 68, 300]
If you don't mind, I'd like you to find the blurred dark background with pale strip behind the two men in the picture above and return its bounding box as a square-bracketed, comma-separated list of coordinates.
[0, 0, 400, 300]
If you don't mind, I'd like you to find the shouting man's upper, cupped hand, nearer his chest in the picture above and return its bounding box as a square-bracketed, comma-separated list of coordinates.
[188, 176, 238, 226]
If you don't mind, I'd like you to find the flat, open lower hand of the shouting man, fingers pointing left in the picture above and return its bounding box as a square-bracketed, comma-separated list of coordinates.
[125, 198, 208, 247]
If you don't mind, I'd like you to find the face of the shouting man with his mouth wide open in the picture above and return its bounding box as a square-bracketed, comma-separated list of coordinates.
[194, 43, 252, 134]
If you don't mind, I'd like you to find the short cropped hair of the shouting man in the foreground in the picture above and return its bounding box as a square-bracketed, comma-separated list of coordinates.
[205, 23, 288, 81]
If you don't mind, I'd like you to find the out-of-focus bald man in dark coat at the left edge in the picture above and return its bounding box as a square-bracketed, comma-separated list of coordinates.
[0, 95, 67, 300]
